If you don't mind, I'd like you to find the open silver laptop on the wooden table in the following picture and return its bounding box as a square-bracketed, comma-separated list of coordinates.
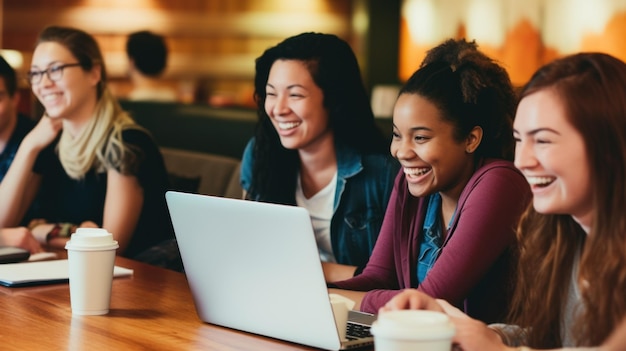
[165, 191, 375, 350]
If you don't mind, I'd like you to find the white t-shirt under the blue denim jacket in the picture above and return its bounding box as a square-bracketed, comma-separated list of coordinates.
[296, 172, 337, 262]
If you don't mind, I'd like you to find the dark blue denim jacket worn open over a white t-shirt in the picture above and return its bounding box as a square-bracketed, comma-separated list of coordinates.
[241, 139, 400, 267]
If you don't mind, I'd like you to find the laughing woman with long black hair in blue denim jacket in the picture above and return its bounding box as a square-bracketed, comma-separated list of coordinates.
[241, 33, 399, 280]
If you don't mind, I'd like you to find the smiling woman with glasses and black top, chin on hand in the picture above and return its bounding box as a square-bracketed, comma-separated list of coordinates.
[0, 27, 173, 257]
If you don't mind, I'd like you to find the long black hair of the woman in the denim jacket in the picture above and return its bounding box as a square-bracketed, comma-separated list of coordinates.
[248, 33, 389, 204]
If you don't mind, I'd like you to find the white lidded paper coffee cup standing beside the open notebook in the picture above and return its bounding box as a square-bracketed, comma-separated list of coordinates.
[65, 228, 119, 315]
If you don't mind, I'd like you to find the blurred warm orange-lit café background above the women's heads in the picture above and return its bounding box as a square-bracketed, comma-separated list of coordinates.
[0, 0, 626, 115]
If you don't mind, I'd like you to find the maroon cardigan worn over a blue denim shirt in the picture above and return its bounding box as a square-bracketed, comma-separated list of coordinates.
[332, 159, 531, 323]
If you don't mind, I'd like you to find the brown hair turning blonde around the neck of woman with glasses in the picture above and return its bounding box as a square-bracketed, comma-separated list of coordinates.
[36, 26, 142, 179]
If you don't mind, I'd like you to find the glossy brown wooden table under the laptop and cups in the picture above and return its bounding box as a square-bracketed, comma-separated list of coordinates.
[0, 257, 326, 351]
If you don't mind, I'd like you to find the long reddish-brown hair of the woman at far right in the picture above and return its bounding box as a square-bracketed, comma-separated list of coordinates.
[511, 53, 626, 348]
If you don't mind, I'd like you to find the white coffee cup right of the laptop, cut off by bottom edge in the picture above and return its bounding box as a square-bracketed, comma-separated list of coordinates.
[370, 310, 455, 351]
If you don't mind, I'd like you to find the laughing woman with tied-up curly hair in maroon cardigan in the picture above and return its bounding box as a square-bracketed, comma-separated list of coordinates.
[330, 40, 530, 321]
